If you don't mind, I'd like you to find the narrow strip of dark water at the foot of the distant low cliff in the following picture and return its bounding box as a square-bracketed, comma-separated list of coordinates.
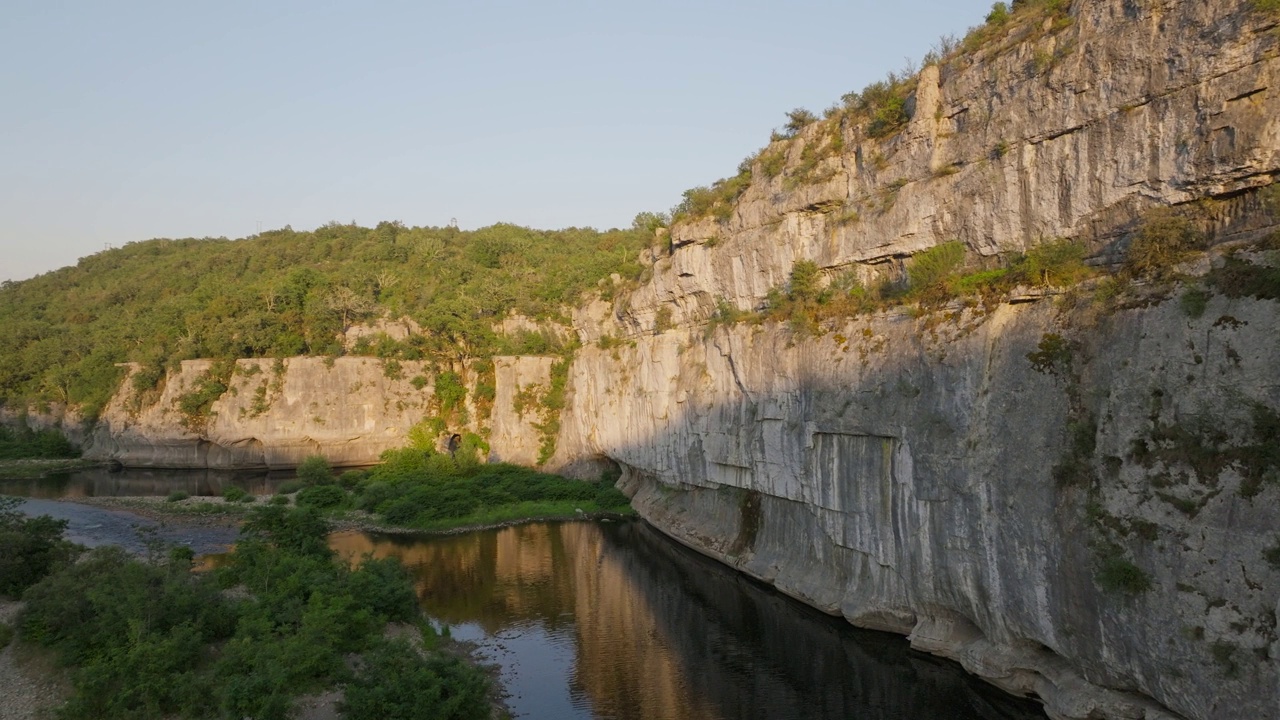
[0, 468, 296, 500]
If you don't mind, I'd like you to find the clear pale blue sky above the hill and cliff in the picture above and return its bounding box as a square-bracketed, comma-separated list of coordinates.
[0, 0, 991, 281]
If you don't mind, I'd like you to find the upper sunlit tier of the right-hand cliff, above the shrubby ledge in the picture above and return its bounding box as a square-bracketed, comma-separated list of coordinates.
[611, 0, 1280, 332]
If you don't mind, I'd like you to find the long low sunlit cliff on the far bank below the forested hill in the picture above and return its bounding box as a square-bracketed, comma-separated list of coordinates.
[86, 357, 431, 469]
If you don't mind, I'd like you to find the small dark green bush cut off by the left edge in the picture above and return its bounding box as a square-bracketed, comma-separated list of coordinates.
[0, 496, 79, 597]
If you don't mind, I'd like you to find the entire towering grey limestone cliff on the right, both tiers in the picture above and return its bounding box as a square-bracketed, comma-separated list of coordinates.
[547, 0, 1280, 719]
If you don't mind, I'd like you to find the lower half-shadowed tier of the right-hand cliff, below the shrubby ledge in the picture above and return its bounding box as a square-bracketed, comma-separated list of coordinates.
[561, 292, 1280, 719]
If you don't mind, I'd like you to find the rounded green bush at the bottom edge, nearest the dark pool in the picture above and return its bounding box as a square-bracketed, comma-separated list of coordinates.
[342, 641, 489, 720]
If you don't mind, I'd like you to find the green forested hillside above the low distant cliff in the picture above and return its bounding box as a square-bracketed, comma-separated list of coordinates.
[0, 223, 653, 418]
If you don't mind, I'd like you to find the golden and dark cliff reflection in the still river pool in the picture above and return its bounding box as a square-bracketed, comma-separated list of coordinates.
[332, 523, 1044, 720]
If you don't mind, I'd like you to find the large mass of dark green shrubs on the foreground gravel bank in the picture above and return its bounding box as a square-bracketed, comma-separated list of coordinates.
[12, 502, 460, 720]
